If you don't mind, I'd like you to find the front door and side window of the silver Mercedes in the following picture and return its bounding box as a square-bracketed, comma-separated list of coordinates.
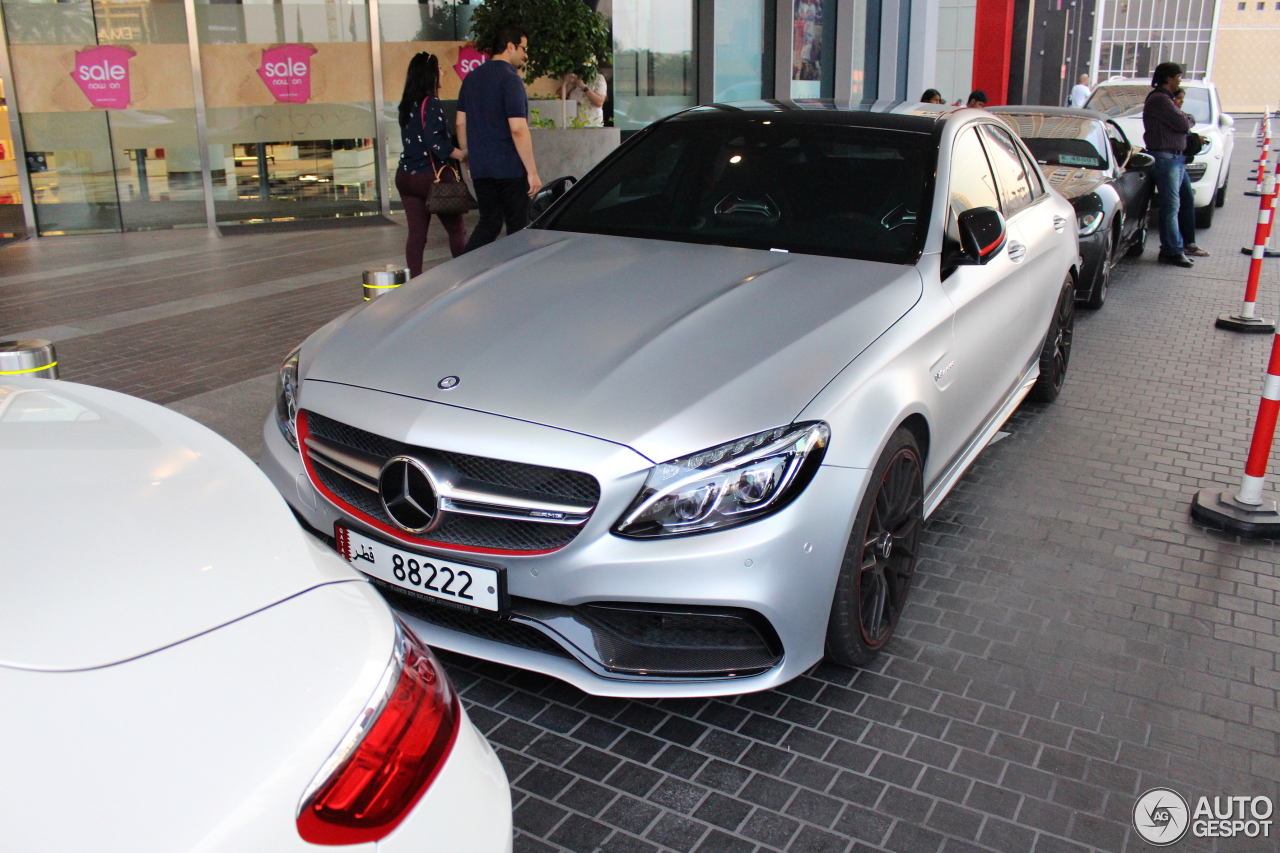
[933, 124, 1027, 468]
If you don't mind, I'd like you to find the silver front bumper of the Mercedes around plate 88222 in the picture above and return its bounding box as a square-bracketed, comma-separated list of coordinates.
[261, 392, 868, 697]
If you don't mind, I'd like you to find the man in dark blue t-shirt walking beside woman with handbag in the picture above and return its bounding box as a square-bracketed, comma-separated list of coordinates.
[457, 27, 543, 252]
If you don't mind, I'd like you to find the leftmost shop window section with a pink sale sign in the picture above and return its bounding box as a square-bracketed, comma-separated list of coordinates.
[4, 0, 205, 234]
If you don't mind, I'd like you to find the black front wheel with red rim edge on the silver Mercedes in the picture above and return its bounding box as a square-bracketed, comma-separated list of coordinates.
[827, 427, 924, 666]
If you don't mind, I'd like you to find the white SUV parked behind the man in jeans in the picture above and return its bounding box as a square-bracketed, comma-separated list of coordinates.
[1084, 77, 1235, 228]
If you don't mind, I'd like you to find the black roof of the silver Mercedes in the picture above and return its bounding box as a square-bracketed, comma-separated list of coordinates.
[664, 99, 982, 133]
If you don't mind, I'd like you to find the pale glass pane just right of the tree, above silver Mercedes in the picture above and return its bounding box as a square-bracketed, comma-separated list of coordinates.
[613, 0, 695, 131]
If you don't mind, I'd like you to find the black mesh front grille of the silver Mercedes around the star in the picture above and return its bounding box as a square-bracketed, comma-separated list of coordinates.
[306, 411, 600, 551]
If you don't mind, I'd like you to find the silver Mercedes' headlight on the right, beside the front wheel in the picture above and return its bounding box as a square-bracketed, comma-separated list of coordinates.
[613, 421, 831, 539]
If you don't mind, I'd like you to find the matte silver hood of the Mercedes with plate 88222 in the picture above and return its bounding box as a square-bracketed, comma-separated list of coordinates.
[301, 231, 922, 461]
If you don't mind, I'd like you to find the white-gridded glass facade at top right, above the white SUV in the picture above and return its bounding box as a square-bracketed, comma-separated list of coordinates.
[1096, 0, 1216, 82]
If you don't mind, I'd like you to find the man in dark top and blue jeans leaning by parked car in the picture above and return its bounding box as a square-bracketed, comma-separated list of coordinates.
[1142, 63, 1194, 268]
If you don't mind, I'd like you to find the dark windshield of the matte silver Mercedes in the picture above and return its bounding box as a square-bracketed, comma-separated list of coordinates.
[539, 118, 937, 263]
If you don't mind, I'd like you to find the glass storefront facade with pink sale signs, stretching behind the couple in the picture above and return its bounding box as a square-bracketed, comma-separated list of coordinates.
[0, 0, 901, 237]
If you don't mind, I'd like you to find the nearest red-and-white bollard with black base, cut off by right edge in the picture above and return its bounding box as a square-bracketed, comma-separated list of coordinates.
[1192, 324, 1280, 537]
